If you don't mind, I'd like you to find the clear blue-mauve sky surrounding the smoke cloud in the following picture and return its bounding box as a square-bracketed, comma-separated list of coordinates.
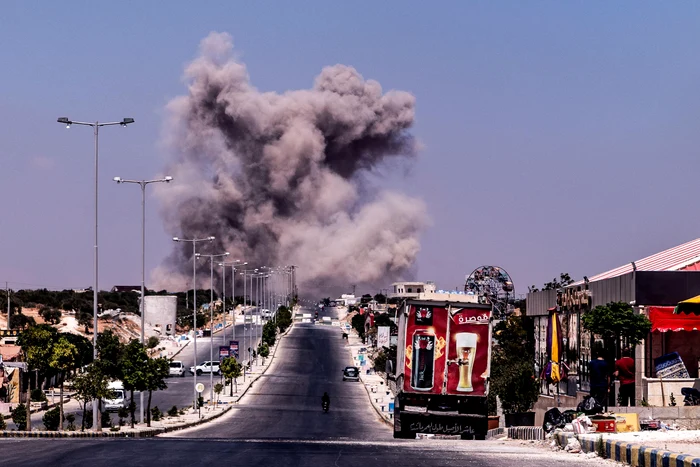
[0, 1, 700, 293]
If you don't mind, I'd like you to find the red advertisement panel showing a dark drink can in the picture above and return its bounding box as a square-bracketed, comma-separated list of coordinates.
[404, 305, 447, 394]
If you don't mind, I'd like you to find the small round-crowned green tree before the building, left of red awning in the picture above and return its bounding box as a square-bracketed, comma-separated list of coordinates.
[581, 302, 651, 359]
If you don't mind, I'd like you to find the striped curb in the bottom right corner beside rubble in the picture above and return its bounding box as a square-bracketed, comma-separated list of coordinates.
[554, 433, 700, 467]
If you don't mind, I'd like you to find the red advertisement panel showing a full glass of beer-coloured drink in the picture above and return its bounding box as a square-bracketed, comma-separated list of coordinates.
[447, 308, 491, 396]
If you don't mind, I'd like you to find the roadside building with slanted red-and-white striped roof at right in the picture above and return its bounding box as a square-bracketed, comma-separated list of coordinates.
[526, 238, 700, 405]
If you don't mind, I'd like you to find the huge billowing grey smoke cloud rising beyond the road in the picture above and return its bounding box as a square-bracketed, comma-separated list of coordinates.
[153, 33, 428, 294]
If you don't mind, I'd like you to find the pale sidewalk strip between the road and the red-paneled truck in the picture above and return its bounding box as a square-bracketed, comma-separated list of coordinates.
[339, 324, 394, 427]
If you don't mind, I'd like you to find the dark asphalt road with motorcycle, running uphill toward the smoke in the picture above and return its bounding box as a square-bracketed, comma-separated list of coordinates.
[5, 308, 604, 467]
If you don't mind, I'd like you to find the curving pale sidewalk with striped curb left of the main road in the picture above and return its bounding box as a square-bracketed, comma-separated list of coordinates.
[0, 325, 294, 438]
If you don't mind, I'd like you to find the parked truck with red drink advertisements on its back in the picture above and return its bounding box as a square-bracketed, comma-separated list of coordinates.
[394, 293, 493, 439]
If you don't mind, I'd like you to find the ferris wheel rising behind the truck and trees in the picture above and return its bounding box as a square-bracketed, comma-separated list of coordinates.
[464, 266, 515, 319]
